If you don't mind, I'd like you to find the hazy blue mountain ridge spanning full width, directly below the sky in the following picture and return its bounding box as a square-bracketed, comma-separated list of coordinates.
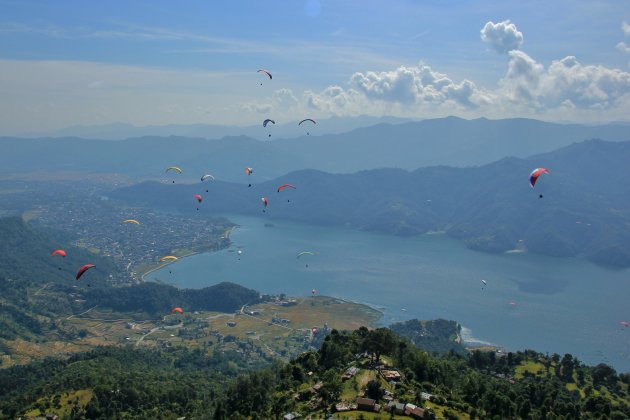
[0, 117, 630, 183]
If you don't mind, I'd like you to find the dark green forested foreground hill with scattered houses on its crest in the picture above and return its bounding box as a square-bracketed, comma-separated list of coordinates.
[0, 328, 630, 419]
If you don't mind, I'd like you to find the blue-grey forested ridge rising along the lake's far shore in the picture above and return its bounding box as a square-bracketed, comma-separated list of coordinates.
[112, 140, 630, 266]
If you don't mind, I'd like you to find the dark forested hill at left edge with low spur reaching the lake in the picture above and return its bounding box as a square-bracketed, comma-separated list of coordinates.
[0, 217, 259, 344]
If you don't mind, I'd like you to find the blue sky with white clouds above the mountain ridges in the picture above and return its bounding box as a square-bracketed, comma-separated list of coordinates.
[0, 0, 630, 135]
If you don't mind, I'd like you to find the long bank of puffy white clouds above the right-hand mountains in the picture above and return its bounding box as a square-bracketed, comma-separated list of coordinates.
[290, 50, 630, 121]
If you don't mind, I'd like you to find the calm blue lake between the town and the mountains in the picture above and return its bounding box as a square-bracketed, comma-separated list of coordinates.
[147, 215, 630, 371]
